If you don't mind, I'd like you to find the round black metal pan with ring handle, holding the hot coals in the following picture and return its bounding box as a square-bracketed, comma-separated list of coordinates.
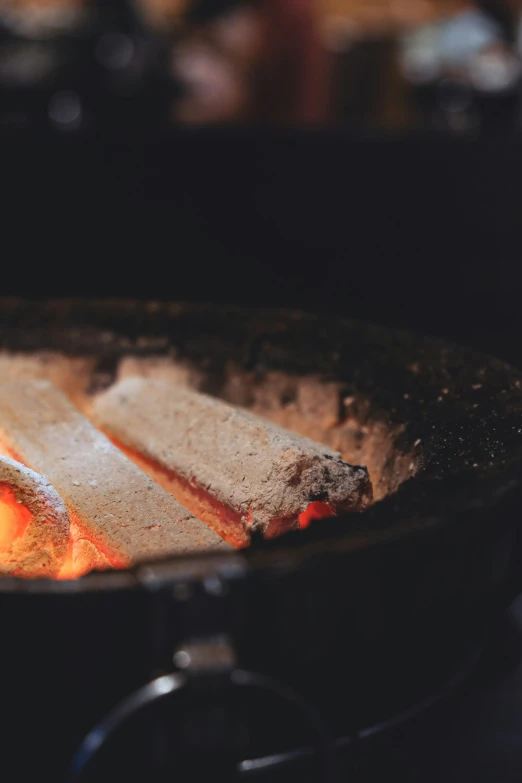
[0, 299, 522, 780]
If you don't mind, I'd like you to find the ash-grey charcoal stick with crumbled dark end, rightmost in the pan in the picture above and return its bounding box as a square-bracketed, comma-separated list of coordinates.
[91, 378, 372, 547]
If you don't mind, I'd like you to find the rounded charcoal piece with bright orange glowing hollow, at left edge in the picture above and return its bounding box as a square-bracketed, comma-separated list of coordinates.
[0, 457, 69, 577]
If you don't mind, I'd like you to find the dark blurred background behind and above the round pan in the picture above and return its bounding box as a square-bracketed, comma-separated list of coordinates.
[0, 0, 522, 366]
